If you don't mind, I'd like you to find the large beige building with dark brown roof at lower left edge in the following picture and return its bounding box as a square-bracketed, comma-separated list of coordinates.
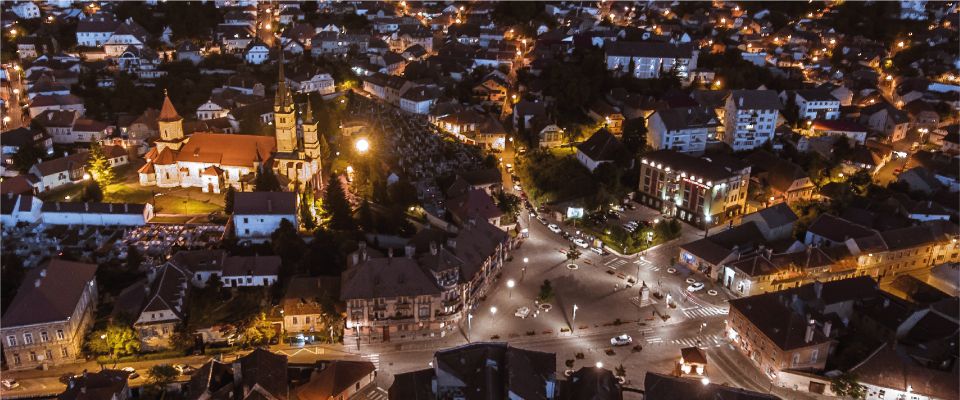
[0, 259, 97, 370]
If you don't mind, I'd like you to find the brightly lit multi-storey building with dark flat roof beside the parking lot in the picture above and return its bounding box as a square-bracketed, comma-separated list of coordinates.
[639, 150, 751, 227]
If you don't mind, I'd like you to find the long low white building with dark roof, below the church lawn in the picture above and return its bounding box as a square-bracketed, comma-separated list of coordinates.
[41, 202, 153, 226]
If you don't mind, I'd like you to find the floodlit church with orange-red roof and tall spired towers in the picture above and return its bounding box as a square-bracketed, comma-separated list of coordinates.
[138, 60, 322, 193]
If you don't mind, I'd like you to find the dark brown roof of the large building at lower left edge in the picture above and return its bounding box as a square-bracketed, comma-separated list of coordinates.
[0, 258, 97, 328]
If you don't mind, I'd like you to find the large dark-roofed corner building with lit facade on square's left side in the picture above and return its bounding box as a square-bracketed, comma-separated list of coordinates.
[340, 219, 511, 343]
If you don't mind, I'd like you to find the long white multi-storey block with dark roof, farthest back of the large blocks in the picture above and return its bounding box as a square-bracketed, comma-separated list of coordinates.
[605, 42, 699, 80]
